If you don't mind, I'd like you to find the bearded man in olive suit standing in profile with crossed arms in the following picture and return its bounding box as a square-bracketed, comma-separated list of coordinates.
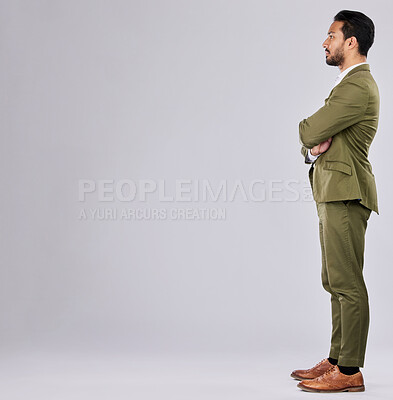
[291, 10, 379, 392]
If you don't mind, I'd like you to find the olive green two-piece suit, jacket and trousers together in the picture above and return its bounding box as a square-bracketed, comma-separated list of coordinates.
[299, 64, 379, 367]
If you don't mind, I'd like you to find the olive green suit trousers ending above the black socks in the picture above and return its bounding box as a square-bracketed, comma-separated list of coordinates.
[317, 200, 371, 367]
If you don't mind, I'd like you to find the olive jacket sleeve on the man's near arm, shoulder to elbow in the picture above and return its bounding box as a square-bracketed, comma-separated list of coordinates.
[299, 80, 369, 149]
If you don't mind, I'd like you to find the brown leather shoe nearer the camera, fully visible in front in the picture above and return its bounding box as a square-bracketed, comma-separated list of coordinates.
[297, 365, 365, 393]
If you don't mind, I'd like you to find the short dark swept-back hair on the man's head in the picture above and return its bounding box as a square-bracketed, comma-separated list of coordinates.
[334, 10, 375, 57]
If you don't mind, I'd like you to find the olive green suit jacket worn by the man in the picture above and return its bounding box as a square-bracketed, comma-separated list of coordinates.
[299, 64, 379, 213]
